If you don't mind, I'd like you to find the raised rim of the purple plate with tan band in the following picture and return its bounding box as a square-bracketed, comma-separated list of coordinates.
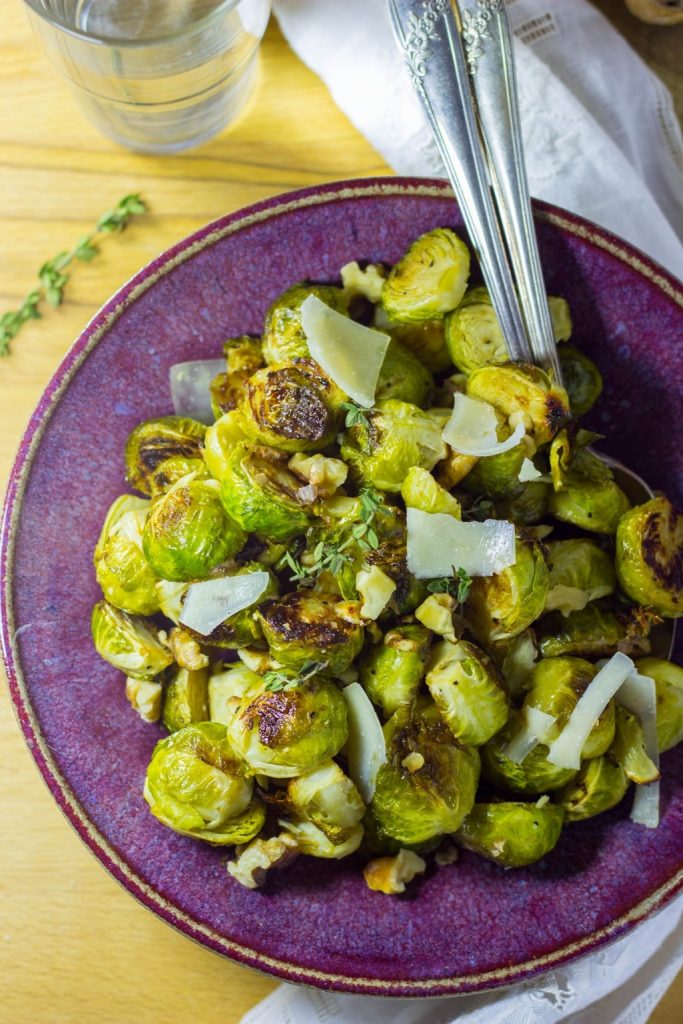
[0, 177, 683, 996]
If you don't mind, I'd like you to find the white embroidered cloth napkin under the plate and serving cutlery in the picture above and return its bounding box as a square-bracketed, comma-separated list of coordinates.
[243, 0, 683, 1024]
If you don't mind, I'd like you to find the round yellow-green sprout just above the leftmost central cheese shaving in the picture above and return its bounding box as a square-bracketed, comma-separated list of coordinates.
[142, 476, 247, 582]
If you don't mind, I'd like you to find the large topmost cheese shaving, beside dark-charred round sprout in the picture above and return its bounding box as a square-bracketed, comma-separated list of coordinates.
[301, 295, 391, 409]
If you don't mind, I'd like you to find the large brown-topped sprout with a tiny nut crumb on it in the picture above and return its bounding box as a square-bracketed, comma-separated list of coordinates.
[369, 700, 479, 848]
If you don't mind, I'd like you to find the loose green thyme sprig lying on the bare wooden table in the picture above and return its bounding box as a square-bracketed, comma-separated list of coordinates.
[0, 194, 146, 355]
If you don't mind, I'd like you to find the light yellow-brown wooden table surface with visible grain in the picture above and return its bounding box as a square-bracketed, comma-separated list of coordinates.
[0, 0, 683, 1024]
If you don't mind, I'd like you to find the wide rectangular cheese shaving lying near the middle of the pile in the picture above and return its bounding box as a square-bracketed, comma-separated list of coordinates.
[405, 508, 515, 580]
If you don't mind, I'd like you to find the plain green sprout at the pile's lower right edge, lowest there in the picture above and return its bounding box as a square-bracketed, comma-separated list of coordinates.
[456, 802, 564, 867]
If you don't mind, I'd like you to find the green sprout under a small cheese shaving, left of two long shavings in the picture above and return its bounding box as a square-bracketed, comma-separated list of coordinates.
[479, 711, 577, 797]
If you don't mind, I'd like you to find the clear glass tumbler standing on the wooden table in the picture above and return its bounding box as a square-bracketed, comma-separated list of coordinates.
[25, 0, 270, 153]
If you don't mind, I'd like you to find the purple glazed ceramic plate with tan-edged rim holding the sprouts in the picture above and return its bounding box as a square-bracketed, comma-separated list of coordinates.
[2, 178, 683, 995]
